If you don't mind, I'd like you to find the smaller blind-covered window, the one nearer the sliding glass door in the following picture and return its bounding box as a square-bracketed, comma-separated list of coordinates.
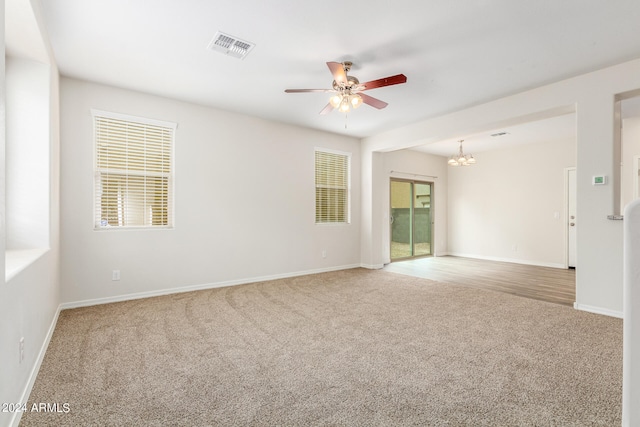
[316, 149, 351, 224]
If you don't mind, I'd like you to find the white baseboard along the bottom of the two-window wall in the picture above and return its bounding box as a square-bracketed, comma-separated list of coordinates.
[60, 264, 361, 310]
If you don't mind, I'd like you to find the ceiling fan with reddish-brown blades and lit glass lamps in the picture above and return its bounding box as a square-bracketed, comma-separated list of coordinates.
[285, 61, 407, 114]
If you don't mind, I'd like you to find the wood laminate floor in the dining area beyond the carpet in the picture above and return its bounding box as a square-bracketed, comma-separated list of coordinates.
[384, 256, 576, 306]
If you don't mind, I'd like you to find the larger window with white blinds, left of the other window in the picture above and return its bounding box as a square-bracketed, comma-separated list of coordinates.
[93, 111, 176, 229]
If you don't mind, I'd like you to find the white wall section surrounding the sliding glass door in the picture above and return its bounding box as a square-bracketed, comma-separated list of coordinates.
[381, 150, 448, 264]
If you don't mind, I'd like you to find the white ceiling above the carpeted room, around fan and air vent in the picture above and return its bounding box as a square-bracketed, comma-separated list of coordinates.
[17, 0, 640, 150]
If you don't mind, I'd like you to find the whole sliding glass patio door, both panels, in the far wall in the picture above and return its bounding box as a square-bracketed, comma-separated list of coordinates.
[390, 178, 433, 261]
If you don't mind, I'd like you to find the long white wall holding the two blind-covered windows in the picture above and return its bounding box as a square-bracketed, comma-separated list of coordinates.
[61, 78, 360, 305]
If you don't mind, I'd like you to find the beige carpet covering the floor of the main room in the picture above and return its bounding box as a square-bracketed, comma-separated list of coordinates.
[21, 269, 622, 426]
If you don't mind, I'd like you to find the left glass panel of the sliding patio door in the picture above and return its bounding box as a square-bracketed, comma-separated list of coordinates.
[391, 181, 413, 259]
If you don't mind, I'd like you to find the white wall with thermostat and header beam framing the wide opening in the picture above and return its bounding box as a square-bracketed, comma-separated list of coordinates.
[361, 60, 640, 316]
